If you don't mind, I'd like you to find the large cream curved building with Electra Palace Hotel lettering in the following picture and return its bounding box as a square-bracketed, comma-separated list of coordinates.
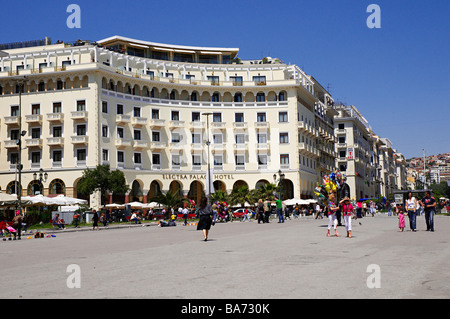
[0, 36, 337, 207]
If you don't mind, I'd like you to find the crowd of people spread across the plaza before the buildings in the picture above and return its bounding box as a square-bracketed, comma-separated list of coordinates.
[2, 191, 442, 241]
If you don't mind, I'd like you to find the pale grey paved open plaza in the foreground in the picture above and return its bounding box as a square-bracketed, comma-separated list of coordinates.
[0, 215, 450, 299]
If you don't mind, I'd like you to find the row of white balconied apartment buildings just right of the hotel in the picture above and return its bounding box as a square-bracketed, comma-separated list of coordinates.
[334, 105, 406, 200]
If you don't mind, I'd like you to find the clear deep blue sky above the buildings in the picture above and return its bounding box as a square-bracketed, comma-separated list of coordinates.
[0, 0, 450, 158]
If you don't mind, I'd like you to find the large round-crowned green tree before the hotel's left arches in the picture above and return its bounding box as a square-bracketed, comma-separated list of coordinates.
[77, 165, 129, 208]
